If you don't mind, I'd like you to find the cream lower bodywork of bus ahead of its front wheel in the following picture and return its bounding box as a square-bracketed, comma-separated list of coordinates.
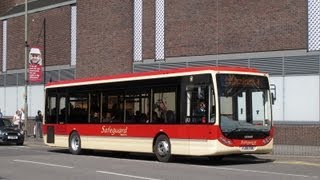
[190, 140, 273, 156]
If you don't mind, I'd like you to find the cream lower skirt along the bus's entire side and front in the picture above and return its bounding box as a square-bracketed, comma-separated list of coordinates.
[43, 135, 273, 156]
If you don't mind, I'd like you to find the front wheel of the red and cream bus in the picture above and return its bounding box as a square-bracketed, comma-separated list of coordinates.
[153, 134, 172, 162]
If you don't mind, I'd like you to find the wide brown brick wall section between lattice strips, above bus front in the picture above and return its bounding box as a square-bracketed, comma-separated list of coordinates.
[165, 0, 307, 57]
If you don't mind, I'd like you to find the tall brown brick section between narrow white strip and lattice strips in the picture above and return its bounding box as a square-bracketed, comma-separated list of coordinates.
[76, 0, 133, 78]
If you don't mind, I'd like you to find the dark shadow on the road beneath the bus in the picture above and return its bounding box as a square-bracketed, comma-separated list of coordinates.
[50, 149, 275, 166]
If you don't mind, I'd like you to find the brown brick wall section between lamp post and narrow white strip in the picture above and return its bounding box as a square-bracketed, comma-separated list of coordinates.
[29, 6, 71, 66]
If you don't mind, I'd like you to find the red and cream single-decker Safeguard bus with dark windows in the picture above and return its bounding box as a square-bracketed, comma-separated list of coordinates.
[43, 67, 273, 162]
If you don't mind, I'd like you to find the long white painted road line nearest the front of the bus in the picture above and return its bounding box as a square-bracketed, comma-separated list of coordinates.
[186, 165, 319, 179]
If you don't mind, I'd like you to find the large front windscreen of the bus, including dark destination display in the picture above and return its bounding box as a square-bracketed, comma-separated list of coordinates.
[217, 74, 271, 138]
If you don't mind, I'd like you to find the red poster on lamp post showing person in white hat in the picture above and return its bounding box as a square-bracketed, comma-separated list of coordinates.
[29, 48, 42, 83]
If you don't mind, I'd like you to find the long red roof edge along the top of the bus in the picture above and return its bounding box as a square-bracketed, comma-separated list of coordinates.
[46, 66, 259, 88]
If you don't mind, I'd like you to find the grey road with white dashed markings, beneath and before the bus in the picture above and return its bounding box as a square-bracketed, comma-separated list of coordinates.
[0, 142, 320, 180]
